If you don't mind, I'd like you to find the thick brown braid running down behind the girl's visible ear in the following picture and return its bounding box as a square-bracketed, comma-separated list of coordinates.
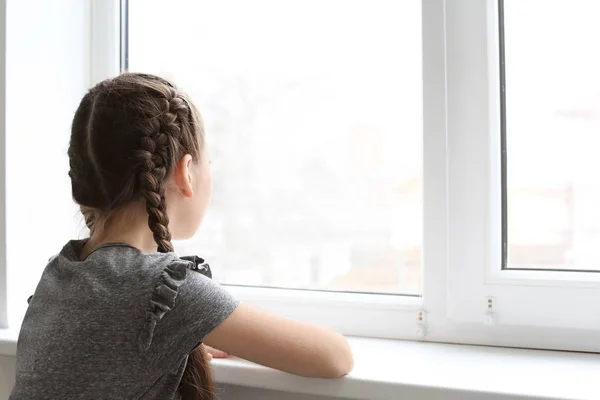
[136, 88, 189, 253]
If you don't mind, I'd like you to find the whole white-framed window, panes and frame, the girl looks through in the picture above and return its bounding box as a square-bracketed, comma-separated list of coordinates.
[0, 0, 600, 352]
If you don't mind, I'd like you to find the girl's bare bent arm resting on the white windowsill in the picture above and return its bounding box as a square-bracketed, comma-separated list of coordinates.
[203, 303, 354, 378]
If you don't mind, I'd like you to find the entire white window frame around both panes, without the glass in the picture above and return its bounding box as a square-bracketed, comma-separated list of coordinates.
[0, 0, 600, 351]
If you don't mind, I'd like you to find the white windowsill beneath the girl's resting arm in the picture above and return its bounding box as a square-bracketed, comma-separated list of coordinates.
[0, 329, 600, 400]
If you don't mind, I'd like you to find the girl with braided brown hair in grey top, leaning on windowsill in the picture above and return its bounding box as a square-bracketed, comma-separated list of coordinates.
[10, 73, 352, 400]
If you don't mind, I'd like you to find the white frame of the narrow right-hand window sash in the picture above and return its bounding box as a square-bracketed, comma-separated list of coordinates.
[446, 0, 600, 351]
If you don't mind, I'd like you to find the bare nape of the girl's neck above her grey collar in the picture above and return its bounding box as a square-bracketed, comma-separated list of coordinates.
[79, 207, 157, 259]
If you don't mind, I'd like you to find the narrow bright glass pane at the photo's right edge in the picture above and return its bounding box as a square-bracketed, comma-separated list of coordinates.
[504, 0, 600, 270]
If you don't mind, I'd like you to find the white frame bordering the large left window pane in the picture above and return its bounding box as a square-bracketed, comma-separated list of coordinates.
[92, 0, 446, 339]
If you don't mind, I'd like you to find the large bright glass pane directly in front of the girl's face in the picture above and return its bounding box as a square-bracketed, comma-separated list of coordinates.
[129, 0, 422, 294]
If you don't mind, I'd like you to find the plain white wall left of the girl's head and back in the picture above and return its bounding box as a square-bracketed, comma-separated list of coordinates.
[6, 0, 90, 326]
